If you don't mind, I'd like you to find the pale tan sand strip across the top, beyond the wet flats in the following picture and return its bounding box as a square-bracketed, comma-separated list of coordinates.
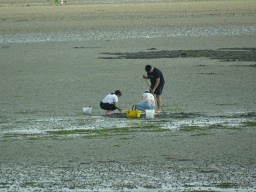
[0, 0, 255, 33]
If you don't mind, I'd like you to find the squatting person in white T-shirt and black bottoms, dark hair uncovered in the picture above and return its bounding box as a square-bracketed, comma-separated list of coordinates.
[100, 90, 122, 115]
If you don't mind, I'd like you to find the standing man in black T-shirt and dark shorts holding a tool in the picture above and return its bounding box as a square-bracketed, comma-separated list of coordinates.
[143, 65, 165, 113]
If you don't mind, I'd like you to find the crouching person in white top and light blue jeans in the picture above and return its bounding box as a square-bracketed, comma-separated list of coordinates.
[135, 90, 155, 112]
